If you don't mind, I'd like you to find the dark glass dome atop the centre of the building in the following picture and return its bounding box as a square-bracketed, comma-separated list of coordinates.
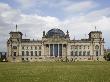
[46, 28, 65, 37]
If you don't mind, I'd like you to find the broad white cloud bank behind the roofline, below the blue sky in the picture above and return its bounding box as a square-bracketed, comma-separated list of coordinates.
[0, 3, 110, 50]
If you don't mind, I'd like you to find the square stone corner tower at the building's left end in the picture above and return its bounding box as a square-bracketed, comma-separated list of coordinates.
[7, 31, 23, 61]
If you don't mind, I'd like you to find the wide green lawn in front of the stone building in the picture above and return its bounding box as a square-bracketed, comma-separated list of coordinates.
[0, 62, 110, 82]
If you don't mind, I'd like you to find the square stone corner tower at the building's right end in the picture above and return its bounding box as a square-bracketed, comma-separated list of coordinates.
[89, 31, 104, 59]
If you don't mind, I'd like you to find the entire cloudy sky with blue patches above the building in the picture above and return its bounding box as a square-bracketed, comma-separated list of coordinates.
[0, 0, 110, 51]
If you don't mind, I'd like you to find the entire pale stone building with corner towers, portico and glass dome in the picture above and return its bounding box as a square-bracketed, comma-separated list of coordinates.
[7, 29, 104, 62]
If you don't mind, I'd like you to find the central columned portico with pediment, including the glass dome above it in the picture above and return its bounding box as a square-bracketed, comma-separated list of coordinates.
[43, 29, 69, 57]
